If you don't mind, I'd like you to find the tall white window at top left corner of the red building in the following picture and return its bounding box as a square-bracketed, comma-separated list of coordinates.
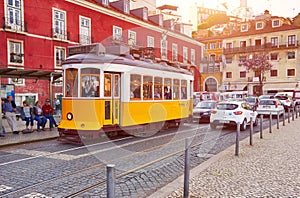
[5, 0, 24, 31]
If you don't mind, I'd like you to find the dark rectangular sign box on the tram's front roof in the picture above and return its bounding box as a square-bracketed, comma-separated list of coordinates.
[68, 43, 105, 56]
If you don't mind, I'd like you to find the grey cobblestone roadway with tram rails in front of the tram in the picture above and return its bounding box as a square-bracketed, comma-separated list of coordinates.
[0, 115, 288, 197]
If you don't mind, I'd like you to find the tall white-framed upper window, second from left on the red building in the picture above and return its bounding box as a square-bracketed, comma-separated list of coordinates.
[53, 9, 67, 40]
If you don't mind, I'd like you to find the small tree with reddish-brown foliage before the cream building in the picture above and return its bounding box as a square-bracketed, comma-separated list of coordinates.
[239, 53, 273, 94]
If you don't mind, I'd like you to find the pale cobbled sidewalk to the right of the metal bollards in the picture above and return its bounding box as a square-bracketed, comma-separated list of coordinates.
[163, 116, 300, 198]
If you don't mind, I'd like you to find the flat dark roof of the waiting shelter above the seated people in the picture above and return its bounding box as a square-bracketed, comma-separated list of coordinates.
[0, 68, 62, 81]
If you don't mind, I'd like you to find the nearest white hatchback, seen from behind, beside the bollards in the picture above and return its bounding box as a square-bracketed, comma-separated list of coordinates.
[210, 101, 258, 131]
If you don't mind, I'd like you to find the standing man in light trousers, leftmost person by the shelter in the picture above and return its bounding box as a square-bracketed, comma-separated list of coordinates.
[2, 95, 19, 134]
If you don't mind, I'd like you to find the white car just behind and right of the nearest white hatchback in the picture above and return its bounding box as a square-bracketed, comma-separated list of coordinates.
[256, 98, 284, 115]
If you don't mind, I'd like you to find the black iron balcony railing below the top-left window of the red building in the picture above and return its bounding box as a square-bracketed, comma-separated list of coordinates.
[2, 17, 28, 32]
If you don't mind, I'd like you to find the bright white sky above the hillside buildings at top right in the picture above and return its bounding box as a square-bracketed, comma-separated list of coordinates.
[156, 0, 300, 21]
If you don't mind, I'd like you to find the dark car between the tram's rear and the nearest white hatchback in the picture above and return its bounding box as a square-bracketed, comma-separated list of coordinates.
[193, 100, 217, 123]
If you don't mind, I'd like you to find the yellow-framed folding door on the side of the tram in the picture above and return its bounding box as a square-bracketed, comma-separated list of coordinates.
[104, 73, 121, 125]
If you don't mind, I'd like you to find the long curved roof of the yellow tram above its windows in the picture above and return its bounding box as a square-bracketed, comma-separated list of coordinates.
[63, 54, 192, 75]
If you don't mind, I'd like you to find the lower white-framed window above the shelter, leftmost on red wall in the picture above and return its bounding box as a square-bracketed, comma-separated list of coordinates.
[8, 41, 24, 64]
